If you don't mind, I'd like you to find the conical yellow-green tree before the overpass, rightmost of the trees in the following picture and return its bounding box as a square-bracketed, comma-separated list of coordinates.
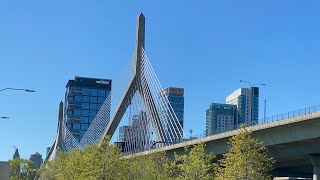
[218, 125, 274, 180]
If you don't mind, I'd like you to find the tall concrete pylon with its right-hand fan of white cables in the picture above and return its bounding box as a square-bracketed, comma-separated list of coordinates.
[100, 13, 184, 152]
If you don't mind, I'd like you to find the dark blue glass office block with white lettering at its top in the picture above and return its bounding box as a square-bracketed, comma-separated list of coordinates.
[64, 77, 111, 142]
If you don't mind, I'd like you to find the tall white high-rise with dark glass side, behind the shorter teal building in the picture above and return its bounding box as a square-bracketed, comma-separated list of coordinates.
[226, 87, 259, 127]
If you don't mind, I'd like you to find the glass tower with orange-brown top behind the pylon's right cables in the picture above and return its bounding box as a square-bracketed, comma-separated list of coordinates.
[160, 87, 184, 141]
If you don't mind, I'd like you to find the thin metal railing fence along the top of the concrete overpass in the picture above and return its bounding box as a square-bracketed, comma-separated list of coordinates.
[176, 105, 320, 143]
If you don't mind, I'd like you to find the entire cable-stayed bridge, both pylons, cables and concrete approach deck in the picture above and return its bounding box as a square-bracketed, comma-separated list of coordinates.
[46, 14, 320, 177]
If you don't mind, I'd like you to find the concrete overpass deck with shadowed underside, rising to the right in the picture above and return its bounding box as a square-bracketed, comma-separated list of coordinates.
[141, 112, 320, 179]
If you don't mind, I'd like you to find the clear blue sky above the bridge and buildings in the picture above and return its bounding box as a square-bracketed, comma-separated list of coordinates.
[0, 0, 320, 160]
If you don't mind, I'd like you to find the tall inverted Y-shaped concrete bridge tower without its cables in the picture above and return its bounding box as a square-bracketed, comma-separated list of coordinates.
[101, 13, 167, 142]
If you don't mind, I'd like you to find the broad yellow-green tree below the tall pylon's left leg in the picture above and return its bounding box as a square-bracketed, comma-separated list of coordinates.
[40, 138, 126, 180]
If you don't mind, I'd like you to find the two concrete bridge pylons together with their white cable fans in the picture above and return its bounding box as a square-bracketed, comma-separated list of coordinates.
[47, 13, 184, 160]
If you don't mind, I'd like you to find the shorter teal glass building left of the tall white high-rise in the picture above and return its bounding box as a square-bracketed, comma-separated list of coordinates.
[206, 103, 237, 136]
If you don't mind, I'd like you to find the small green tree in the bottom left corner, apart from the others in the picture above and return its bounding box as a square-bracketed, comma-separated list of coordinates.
[9, 158, 37, 180]
